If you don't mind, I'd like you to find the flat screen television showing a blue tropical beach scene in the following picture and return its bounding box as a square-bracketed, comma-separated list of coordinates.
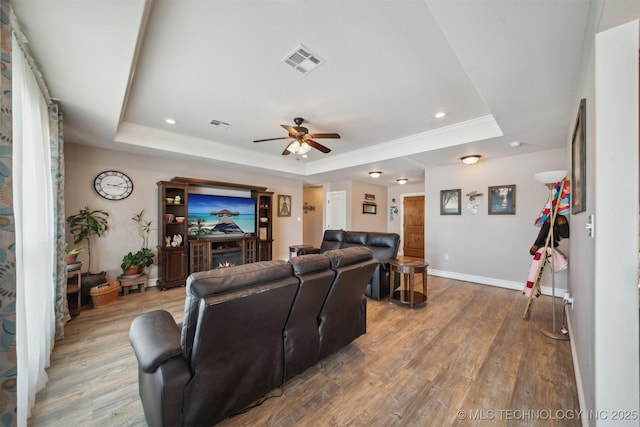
[187, 193, 256, 237]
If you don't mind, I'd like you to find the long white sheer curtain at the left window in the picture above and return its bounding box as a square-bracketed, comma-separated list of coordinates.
[12, 31, 55, 426]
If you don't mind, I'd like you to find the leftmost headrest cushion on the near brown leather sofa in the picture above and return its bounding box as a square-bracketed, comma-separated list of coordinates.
[187, 260, 292, 298]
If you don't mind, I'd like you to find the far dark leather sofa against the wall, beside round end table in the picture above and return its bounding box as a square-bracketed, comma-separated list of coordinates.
[298, 230, 400, 300]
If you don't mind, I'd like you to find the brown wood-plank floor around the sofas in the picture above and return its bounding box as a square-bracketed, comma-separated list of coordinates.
[29, 277, 581, 427]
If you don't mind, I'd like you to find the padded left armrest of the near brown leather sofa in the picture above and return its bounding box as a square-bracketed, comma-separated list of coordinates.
[129, 310, 182, 373]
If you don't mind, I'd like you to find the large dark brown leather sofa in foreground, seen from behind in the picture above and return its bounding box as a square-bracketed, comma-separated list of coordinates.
[129, 247, 378, 426]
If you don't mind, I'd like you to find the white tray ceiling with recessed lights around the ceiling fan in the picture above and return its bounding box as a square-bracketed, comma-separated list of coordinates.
[13, 0, 638, 185]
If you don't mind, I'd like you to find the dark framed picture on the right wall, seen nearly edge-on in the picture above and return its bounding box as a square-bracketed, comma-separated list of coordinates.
[571, 99, 587, 214]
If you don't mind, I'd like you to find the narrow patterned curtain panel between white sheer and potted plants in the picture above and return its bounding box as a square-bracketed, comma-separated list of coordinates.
[49, 102, 71, 340]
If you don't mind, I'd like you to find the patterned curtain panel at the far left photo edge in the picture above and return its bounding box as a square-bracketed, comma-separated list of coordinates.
[0, 0, 18, 426]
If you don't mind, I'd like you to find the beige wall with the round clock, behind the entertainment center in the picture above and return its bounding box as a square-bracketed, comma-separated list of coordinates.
[65, 144, 303, 284]
